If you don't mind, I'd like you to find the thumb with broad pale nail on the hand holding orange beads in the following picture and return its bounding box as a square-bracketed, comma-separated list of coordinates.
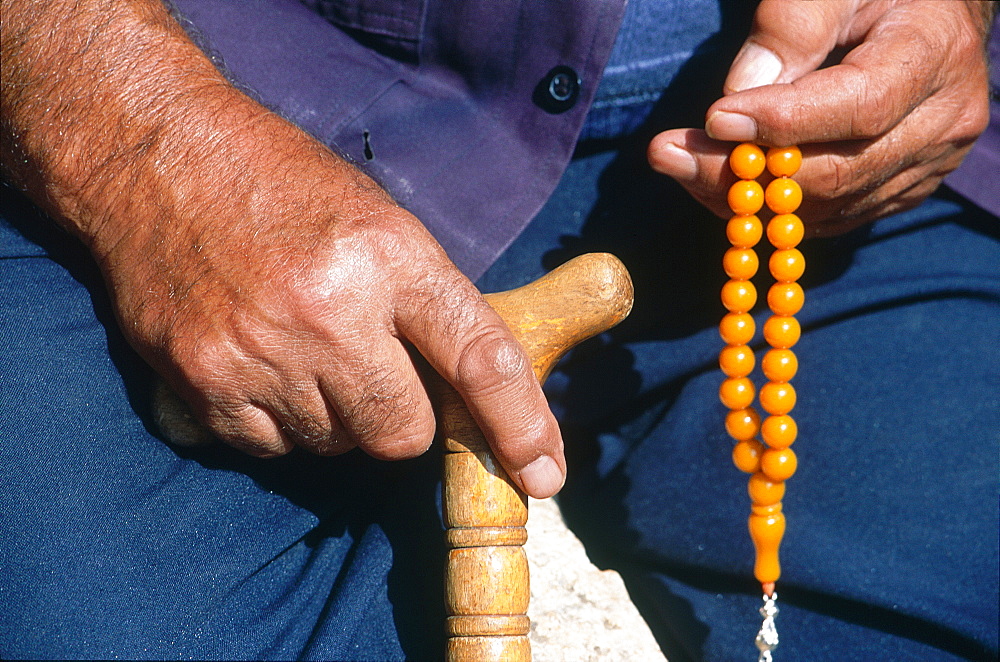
[723, 0, 858, 95]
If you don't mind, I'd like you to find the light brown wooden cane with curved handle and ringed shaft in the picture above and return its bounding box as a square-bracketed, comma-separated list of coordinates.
[436, 253, 632, 662]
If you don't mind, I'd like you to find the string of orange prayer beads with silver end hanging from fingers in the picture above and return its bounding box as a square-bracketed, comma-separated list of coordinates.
[719, 143, 805, 662]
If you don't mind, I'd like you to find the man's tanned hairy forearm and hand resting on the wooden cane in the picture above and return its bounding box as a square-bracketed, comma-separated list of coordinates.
[3, 0, 565, 497]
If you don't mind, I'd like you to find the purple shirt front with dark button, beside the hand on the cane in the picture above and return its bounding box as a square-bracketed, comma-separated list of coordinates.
[176, 0, 625, 279]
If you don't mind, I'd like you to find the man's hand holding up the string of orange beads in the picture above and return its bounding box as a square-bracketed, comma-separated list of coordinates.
[649, 0, 993, 235]
